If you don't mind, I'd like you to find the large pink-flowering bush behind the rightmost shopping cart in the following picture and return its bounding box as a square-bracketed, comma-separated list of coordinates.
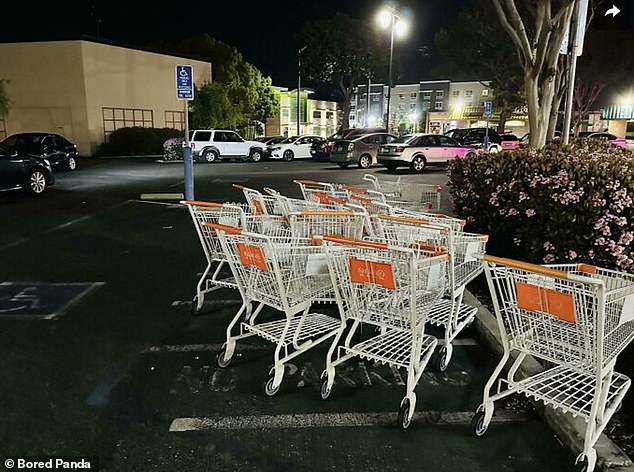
[447, 139, 634, 271]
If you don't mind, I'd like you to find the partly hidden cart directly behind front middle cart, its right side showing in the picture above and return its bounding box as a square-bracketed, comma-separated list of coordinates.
[373, 215, 488, 372]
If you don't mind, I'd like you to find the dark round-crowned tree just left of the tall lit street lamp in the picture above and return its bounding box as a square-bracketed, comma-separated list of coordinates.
[300, 13, 386, 128]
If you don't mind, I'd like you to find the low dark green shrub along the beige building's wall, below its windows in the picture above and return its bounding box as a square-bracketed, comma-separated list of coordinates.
[96, 126, 183, 156]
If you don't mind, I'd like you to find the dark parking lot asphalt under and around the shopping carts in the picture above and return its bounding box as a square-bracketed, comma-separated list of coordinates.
[0, 159, 628, 471]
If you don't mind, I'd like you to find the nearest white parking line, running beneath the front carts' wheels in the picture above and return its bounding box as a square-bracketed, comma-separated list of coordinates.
[169, 410, 528, 433]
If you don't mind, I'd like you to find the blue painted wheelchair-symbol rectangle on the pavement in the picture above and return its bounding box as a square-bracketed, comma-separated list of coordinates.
[0, 282, 103, 319]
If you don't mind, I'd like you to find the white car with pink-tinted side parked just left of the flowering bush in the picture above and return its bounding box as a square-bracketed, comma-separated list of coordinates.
[377, 133, 478, 172]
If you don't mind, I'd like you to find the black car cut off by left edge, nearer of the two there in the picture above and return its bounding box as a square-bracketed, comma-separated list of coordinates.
[0, 143, 55, 195]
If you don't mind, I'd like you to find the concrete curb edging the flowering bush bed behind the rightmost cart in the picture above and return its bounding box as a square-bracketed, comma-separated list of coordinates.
[464, 290, 634, 472]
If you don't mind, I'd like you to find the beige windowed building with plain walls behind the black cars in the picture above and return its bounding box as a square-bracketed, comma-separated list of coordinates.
[0, 40, 211, 155]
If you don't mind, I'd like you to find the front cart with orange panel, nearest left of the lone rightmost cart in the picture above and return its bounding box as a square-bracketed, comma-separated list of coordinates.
[320, 237, 447, 429]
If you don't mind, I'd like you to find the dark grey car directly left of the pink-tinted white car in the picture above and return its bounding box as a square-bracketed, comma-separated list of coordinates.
[330, 133, 396, 169]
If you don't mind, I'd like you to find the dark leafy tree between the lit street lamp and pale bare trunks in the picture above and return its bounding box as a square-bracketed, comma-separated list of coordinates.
[434, 0, 525, 131]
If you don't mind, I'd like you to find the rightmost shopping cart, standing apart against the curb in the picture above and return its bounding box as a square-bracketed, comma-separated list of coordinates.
[472, 256, 634, 472]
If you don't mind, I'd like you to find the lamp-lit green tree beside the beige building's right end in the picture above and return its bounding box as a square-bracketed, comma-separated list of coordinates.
[152, 34, 279, 133]
